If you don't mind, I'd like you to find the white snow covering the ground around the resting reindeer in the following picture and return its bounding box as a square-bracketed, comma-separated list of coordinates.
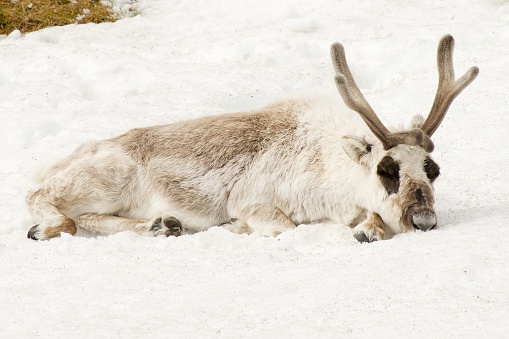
[0, 0, 509, 338]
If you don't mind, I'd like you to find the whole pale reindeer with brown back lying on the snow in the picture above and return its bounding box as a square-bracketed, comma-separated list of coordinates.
[26, 35, 479, 242]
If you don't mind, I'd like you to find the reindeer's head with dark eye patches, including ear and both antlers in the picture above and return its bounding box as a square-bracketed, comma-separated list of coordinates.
[331, 35, 479, 235]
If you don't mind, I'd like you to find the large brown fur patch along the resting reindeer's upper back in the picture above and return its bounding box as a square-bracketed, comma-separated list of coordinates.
[113, 102, 297, 169]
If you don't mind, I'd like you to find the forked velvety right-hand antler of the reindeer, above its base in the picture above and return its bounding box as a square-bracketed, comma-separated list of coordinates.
[421, 35, 479, 137]
